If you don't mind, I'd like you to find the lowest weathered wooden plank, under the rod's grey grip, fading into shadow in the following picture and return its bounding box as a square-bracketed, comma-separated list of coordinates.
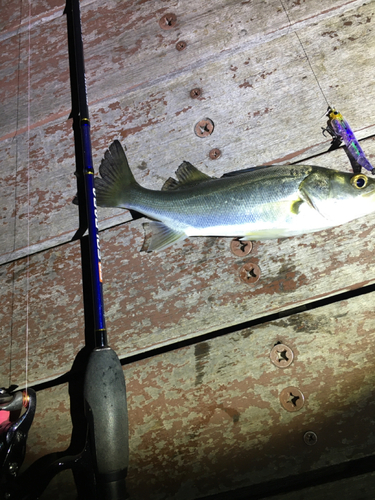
[19, 292, 375, 500]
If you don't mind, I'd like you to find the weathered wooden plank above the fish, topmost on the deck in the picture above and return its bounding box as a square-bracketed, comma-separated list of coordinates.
[0, 2, 375, 262]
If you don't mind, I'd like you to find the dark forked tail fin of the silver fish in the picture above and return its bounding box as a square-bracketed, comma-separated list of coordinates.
[95, 140, 138, 207]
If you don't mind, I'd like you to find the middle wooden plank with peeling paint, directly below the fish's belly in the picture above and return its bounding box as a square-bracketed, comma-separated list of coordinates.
[0, 172, 375, 383]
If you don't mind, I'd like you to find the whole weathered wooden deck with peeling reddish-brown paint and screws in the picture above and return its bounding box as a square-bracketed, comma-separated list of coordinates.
[0, 0, 375, 500]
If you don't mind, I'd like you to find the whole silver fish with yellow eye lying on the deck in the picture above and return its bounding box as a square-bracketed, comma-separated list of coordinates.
[95, 140, 375, 252]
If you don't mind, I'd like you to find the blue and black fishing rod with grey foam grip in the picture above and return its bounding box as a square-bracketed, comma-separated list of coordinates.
[66, 0, 129, 500]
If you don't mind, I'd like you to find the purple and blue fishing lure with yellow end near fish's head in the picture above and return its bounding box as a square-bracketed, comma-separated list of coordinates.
[323, 107, 375, 175]
